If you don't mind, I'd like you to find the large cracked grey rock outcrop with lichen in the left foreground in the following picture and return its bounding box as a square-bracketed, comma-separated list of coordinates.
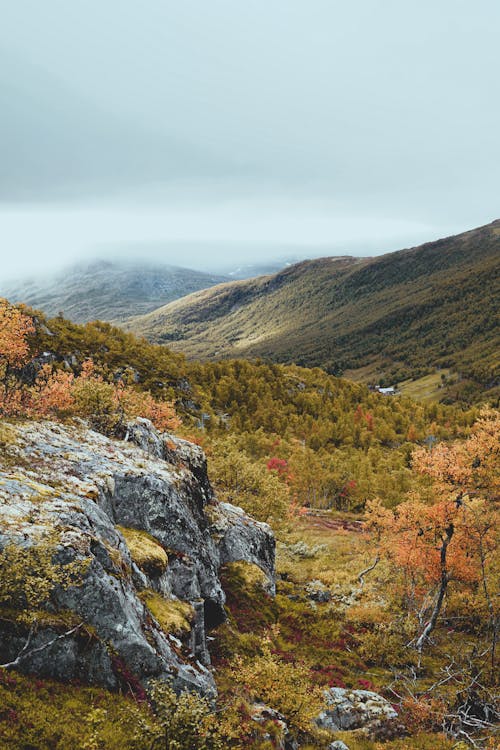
[0, 420, 275, 696]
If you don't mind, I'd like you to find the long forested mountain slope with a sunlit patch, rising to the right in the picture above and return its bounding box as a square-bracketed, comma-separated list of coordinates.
[129, 221, 500, 400]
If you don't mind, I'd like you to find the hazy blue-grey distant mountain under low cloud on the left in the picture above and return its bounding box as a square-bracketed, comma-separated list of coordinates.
[0, 260, 229, 323]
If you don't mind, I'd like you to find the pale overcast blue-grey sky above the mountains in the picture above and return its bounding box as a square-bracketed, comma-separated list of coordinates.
[0, 0, 500, 278]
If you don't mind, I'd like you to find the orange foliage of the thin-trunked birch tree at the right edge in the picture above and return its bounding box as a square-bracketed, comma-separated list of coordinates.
[367, 409, 500, 612]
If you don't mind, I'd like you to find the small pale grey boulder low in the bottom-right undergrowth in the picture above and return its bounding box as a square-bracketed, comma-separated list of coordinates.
[316, 687, 397, 733]
